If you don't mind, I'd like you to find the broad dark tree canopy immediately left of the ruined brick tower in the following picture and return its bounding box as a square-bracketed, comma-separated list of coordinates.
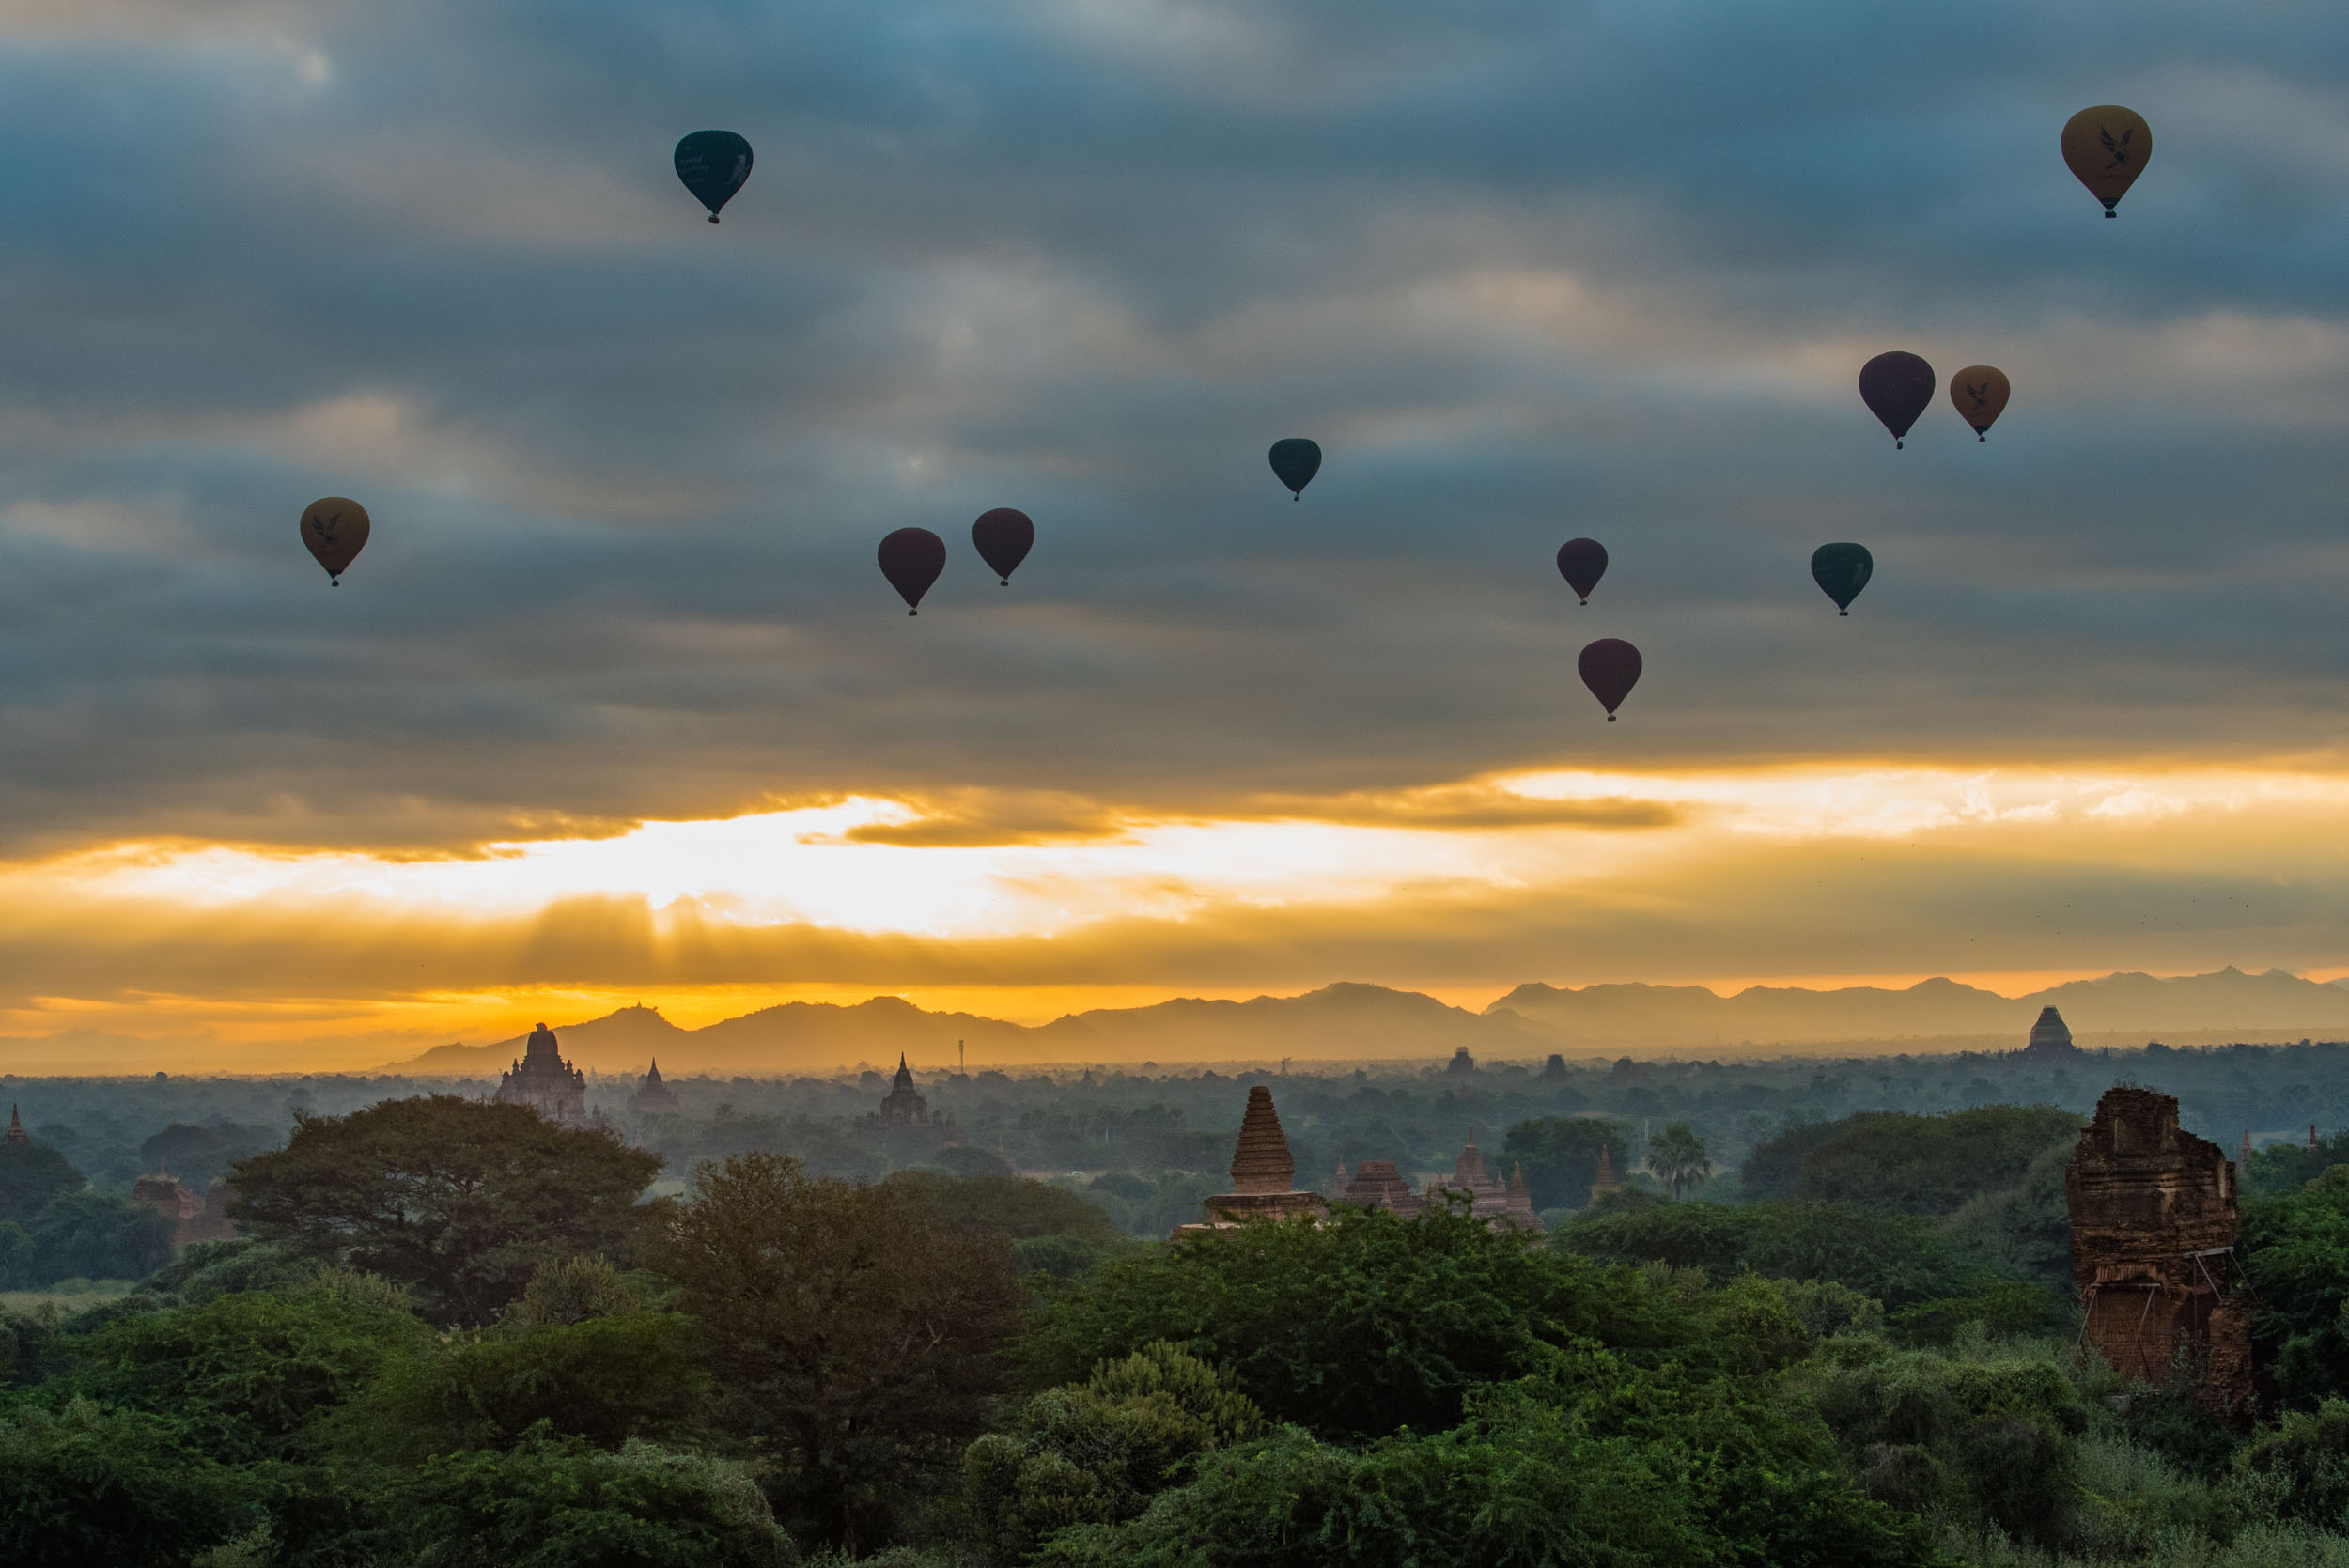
[1743, 1106, 2081, 1214]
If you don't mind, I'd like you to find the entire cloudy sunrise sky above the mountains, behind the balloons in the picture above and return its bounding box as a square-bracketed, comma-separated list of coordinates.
[0, 0, 2349, 1065]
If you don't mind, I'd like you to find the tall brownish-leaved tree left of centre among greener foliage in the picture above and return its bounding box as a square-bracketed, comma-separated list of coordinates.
[646, 1155, 1019, 1552]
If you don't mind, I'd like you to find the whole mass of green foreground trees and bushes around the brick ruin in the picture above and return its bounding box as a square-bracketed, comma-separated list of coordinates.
[0, 1084, 2349, 1568]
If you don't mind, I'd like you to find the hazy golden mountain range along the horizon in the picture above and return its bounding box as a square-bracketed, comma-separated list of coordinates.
[393, 967, 2349, 1078]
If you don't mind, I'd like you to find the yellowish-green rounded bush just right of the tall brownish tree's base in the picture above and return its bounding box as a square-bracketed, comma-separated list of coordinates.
[963, 1341, 1264, 1561]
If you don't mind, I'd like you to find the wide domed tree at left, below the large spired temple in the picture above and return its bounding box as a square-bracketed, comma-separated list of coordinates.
[228, 1094, 661, 1324]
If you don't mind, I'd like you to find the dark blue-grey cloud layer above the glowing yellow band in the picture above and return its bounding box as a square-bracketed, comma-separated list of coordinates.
[0, 0, 2349, 847]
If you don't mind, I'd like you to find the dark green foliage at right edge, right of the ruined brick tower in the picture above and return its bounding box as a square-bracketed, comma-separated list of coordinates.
[2236, 1164, 2349, 1406]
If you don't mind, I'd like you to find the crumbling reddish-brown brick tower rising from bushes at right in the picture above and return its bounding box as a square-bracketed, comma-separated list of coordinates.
[2065, 1089, 2253, 1411]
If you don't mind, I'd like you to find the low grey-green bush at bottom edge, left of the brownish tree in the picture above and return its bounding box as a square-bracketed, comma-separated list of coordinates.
[390, 1432, 797, 1568]
